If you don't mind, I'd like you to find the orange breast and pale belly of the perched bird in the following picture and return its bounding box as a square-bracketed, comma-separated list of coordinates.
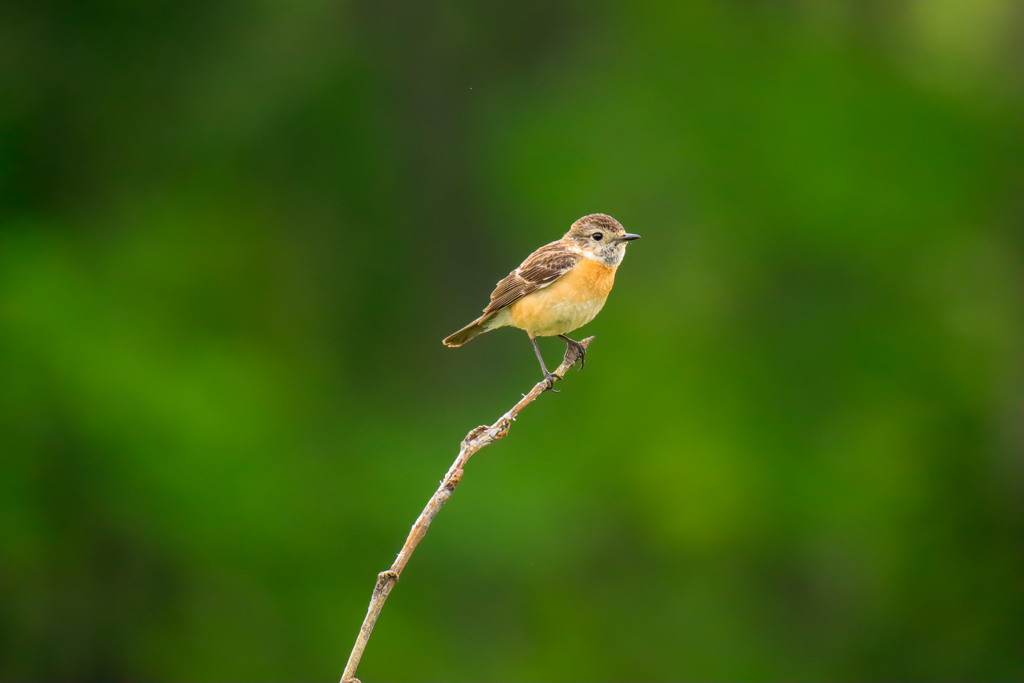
[508, 258, 617, 337]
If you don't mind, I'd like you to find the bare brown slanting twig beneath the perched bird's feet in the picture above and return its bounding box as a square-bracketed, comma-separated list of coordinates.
[341, 337, 594, 683]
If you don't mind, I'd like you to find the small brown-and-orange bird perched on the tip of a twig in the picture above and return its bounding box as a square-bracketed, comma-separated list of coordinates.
[442, 213, 640, 391]
